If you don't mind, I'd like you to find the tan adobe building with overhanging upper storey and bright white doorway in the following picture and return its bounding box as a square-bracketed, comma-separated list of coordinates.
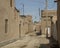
[41, 10, 57, 37]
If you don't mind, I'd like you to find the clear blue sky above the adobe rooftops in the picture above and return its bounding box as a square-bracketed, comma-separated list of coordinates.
[15, 0, 57, 21]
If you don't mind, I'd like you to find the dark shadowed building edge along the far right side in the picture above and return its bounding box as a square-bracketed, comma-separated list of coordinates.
[55, 0, 60, 48]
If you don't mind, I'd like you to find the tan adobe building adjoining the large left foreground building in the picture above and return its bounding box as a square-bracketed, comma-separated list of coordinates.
[19, 15, 28, 37]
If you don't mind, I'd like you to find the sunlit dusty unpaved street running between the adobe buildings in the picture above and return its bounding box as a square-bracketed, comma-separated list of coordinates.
[1, 32, 49, 48]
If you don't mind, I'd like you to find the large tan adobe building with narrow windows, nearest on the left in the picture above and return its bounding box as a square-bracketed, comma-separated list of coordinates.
[0, 0, 19, 43]
